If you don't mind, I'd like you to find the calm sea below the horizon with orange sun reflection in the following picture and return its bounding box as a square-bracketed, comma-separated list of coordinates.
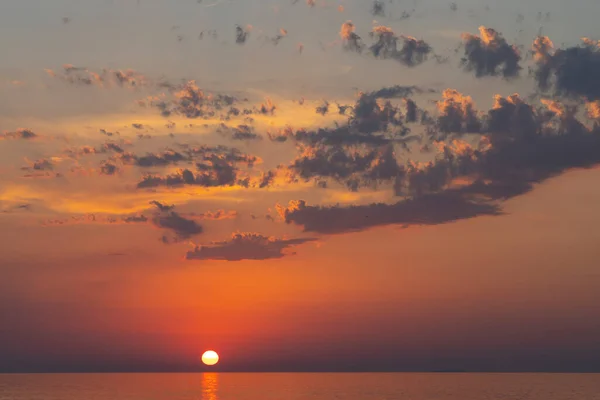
[0, 373, 600, 400]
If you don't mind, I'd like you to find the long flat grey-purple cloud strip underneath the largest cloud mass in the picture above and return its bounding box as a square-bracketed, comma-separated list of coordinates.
[277, 192, 500, 234]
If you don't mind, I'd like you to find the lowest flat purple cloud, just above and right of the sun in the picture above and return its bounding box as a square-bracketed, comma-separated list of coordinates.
[186, 233, 316, 261]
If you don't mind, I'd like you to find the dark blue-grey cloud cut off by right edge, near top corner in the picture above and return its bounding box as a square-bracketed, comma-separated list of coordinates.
[533, 36, 600, 101]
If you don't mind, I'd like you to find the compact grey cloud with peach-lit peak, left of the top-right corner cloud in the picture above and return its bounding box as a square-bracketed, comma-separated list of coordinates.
[461, 26, 521, 78]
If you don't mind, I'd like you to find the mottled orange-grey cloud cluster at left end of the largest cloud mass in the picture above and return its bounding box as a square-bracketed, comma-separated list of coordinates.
[269, 86, 432, 190]
